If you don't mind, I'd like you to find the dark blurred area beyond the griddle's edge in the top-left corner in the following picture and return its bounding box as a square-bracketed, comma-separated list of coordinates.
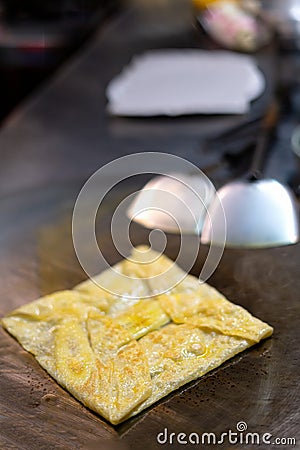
[0, 0, 119, 126]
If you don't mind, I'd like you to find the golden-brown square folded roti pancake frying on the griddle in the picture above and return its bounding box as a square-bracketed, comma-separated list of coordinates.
[2, 247, 273, 424]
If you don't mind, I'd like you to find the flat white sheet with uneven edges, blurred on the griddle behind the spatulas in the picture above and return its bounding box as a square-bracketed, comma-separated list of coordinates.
[106, 49, 265, 116]
